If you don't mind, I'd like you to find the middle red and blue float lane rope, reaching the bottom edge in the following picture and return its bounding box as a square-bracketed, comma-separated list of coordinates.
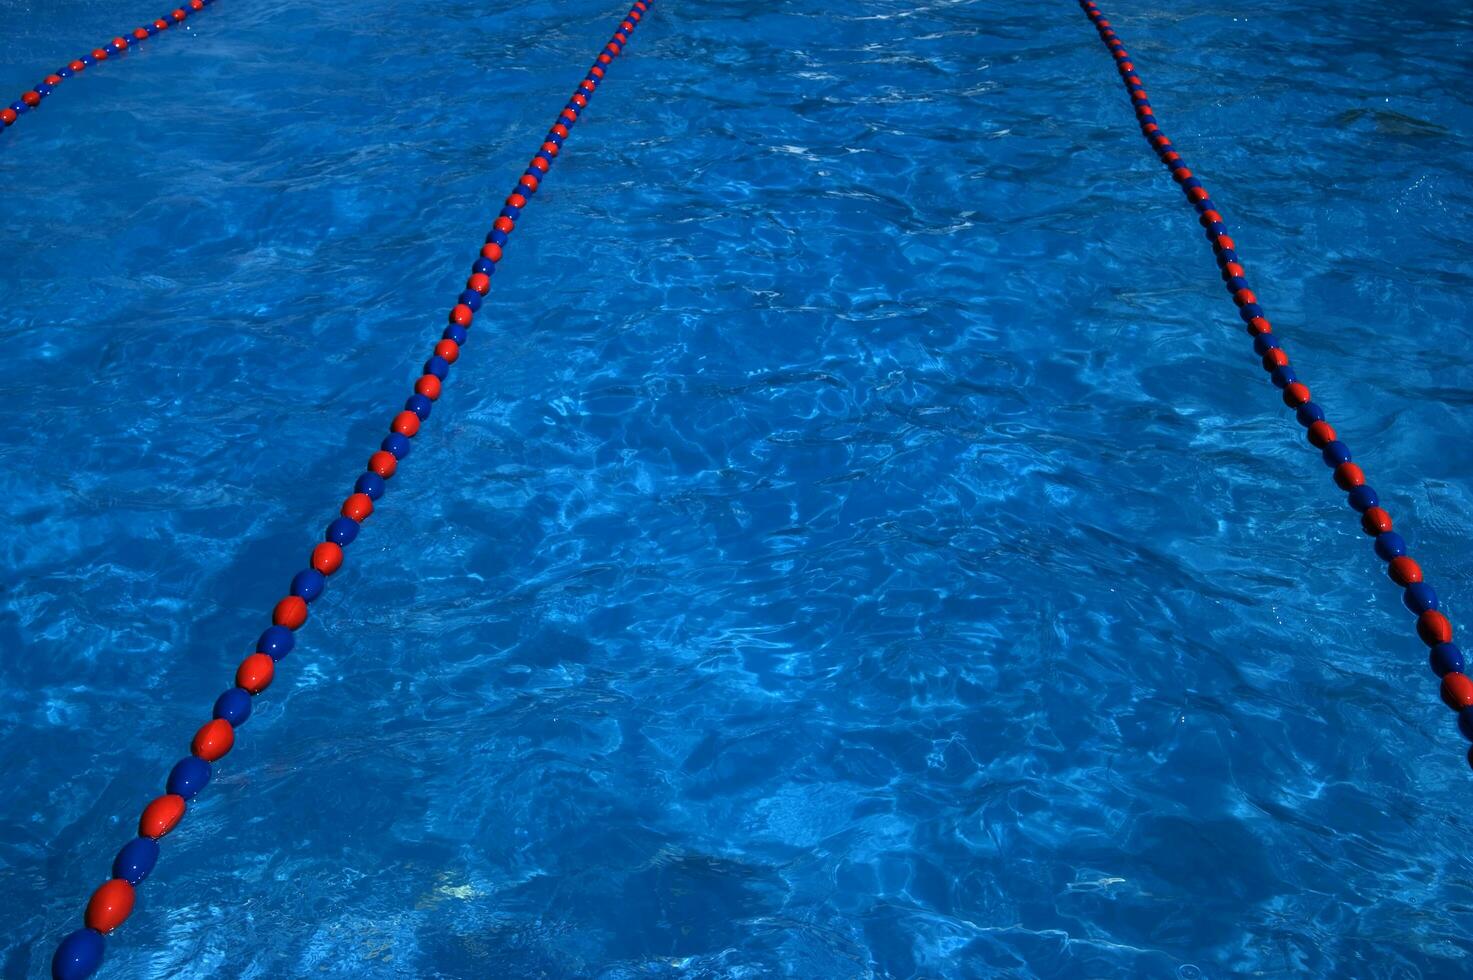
[52, 0, 653, 980]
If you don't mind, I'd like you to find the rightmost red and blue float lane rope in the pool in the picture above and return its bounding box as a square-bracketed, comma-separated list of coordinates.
[1080, 0, 1473, 765]
